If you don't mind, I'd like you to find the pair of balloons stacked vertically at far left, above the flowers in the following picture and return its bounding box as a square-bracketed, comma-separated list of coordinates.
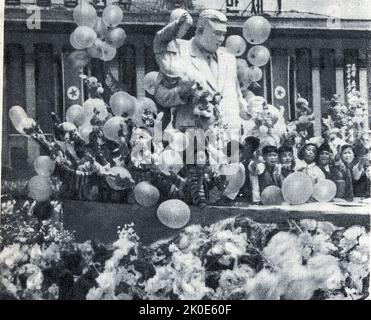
[28, 156, 55, 202]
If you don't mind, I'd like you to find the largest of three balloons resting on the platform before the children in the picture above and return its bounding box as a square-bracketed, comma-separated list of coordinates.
[282, 172, 313, 204]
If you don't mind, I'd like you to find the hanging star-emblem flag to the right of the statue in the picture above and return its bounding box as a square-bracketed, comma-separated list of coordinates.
[271, 49, 290, 120]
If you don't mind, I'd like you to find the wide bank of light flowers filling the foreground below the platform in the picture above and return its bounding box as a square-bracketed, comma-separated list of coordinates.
[0, 195, 369, 300]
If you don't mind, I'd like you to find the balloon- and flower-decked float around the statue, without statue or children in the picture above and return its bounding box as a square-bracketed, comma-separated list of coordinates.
[0, 2, 370, 300]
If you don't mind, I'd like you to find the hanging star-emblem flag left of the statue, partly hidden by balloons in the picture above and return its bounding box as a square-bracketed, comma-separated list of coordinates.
[62, 52, 84, 115]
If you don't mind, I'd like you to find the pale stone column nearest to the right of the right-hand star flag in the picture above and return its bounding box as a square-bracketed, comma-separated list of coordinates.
[312, 48, 322, 136]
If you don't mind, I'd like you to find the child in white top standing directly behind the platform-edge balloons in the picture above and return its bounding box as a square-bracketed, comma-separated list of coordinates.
[295, 143, 326, 183]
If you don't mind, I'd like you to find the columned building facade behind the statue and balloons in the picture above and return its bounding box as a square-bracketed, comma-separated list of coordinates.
[2, 0, 371, 176]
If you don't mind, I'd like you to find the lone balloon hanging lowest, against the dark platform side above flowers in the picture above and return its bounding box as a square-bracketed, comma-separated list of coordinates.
[157, 199, 191, 229]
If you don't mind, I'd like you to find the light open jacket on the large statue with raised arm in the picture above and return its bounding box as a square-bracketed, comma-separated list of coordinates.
[155, 38, 247, 129]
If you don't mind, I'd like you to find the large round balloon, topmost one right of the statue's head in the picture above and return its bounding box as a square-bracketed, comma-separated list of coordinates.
[243, 16, 271, 44]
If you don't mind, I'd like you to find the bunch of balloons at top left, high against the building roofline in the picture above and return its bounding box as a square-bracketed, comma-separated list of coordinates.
[69, 0, 126, 69]
